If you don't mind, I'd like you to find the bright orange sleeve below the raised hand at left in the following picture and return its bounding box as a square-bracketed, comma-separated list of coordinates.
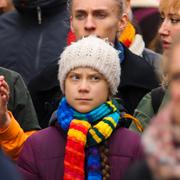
[0, 112, 36, 160]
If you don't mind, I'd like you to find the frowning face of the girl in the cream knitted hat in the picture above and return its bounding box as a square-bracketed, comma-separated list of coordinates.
[65, 67, 109, 113]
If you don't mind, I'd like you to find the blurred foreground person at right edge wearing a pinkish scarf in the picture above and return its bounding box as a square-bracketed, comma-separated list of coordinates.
[125, 34, 180, 180]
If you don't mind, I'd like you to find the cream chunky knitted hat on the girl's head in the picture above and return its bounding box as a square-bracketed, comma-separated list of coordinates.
[58, 36, 120, 95]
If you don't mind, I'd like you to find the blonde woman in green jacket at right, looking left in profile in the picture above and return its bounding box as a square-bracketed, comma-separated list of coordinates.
[131, 0, 180, 132]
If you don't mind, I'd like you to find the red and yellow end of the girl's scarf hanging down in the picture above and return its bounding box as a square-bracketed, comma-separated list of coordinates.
[64, 120, 89, 180]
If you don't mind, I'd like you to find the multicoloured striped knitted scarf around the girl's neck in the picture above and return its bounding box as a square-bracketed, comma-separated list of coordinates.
[57, 98, 120, 180]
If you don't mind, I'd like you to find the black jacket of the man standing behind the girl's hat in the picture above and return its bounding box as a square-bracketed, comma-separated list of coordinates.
[28, 44, 159, 128]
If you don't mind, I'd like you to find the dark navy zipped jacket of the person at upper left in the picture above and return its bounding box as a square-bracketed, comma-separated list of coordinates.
[0, 0, 69, 83]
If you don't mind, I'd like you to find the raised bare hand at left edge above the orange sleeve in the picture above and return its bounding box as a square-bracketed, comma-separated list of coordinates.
[0, 76, 10, 128]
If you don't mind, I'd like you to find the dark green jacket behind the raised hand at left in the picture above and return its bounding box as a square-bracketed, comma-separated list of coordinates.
[0, 67, 40, 131]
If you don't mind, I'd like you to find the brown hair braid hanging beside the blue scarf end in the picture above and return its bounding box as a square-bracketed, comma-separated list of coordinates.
[99, 142, 110, 180]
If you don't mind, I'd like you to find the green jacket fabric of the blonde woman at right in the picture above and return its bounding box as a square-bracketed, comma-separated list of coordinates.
[129, 90, 169, 133]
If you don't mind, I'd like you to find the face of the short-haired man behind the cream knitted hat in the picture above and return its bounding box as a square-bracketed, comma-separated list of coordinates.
[71, 0, 125, 43]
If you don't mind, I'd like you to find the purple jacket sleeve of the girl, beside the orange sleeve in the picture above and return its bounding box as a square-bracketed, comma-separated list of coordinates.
[17, 138, 41, 180]
